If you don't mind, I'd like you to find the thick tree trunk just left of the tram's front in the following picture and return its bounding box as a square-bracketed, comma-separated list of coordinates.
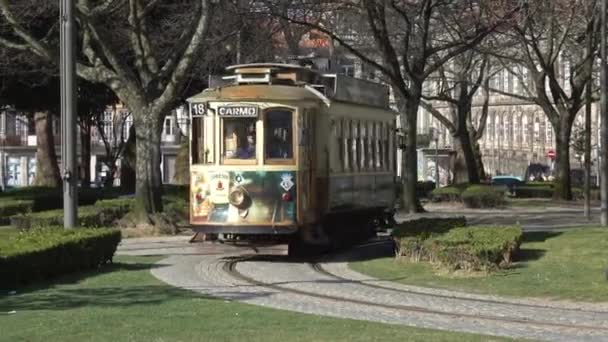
[134, 113, 163, 222]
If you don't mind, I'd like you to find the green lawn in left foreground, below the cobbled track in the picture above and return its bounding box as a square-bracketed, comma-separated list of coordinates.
[0, 257, 505, 342]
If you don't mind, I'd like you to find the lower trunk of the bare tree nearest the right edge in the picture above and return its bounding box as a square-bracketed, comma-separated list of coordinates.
[553, 122, 572, 201]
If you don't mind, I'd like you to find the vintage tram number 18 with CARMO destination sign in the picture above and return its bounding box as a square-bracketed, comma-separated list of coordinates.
[188, 63, 396, 248]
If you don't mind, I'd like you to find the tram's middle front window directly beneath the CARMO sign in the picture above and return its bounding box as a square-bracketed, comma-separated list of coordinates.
[224, 118, 256, 160]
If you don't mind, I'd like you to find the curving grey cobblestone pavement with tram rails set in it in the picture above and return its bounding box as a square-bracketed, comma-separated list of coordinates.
[119, 239, 608, 341]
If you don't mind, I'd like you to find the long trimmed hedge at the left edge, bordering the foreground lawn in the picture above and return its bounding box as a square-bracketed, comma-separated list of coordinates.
[0, 228, 121, 289]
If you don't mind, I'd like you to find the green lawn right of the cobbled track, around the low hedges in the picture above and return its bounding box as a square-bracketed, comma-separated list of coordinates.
[351, 228, 608, 302]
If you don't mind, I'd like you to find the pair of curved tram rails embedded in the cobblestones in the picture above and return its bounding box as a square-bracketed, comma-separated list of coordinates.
[222, 256, 608, 333]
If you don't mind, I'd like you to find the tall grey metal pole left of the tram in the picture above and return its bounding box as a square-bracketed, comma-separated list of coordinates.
[59, 0, 78, 229]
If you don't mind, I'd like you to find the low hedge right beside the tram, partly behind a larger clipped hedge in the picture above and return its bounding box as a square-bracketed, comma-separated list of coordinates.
[393, 216, 467, 261]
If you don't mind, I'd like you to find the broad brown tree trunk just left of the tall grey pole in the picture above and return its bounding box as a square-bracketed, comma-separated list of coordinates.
[34, 112, 61, 187]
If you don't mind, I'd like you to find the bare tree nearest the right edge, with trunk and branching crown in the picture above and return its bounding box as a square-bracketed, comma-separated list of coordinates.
[492, 0, 599, 200]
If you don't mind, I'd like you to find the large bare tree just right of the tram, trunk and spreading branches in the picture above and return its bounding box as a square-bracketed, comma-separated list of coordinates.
[269, 0, 517, 212]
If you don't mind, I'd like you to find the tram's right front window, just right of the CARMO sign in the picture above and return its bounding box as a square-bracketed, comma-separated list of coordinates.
[264, 109, 293, 159]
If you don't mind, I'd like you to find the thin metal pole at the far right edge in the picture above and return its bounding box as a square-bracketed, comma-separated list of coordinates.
[600, 0, 608, 227]
